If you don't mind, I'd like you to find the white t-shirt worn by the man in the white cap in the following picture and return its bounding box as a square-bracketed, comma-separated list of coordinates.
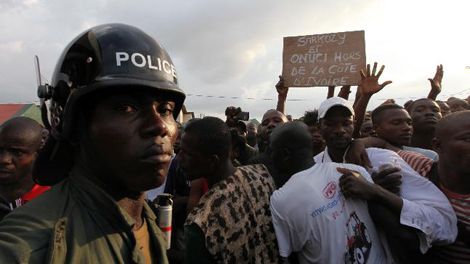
[314, 148, 457, 253]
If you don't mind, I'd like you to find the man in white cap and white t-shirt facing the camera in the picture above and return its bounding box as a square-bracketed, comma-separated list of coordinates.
[315, 97, 457, 258]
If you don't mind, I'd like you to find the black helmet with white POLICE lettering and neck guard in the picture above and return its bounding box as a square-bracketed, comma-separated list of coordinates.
[33, 24, 185, 185]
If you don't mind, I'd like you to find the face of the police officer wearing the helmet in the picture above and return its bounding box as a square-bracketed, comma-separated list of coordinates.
[86, 92, 177, 192]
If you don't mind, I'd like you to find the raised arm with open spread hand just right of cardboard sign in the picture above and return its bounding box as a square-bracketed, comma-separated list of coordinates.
[353, 62, 392, 138]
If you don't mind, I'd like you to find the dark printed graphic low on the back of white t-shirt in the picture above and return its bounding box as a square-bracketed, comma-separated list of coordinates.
[344, 212, 372, 264]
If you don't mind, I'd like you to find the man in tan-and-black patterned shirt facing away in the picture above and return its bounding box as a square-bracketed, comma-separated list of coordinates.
[179, 117, 279, 263]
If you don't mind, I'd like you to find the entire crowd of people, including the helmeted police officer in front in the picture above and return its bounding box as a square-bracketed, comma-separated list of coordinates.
[0, 24, 470, 263]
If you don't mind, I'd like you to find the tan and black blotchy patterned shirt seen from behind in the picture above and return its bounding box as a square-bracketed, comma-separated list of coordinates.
[185, 164, 279, 263]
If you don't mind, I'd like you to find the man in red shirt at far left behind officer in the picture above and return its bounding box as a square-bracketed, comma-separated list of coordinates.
[0, 117, 49, 219]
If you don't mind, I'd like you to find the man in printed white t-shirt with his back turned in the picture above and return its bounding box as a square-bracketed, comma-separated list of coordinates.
[270, 122, 391, 263]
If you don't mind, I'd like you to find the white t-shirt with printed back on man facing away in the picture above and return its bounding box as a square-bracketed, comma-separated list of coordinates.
[271, 163, 388, 263]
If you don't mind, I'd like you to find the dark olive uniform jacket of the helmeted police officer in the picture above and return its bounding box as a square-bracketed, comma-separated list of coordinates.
[0, 168, 168, 264]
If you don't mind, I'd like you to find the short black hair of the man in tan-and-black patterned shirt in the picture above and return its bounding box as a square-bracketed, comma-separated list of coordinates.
[184, 116, 232, 158]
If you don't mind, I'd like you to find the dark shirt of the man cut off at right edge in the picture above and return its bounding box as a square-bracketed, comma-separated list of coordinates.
[431, 184, 470, 264]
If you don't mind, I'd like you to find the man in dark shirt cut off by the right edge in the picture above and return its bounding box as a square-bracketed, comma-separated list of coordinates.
[430, 110, 470, 263]
